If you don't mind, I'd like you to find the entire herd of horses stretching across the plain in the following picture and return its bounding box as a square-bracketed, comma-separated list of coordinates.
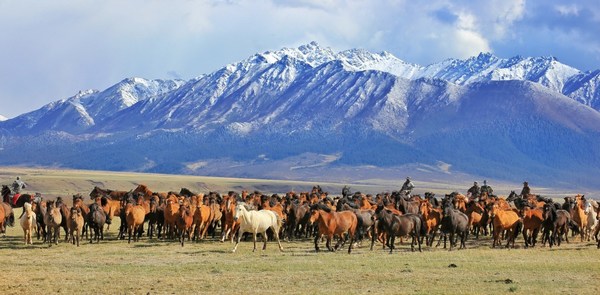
[0, 184, 600, 253]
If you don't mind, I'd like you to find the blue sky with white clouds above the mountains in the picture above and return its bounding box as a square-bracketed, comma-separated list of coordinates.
[0, 0, 600, 117]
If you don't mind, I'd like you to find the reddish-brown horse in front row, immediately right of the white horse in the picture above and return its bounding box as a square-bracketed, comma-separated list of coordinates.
[309, 203, 359, 254]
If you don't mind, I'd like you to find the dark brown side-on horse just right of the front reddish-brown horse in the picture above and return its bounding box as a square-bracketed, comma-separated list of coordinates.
[371, 206, 425, 254]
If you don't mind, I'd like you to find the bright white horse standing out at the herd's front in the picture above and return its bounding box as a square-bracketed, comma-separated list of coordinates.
[232, 203, 283, 252]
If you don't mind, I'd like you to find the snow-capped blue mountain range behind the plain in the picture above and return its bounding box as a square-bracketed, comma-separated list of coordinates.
[0, 42, 600, 188]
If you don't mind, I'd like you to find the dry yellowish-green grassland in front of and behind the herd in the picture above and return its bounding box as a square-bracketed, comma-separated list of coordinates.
[0, 168, 600, 294]
